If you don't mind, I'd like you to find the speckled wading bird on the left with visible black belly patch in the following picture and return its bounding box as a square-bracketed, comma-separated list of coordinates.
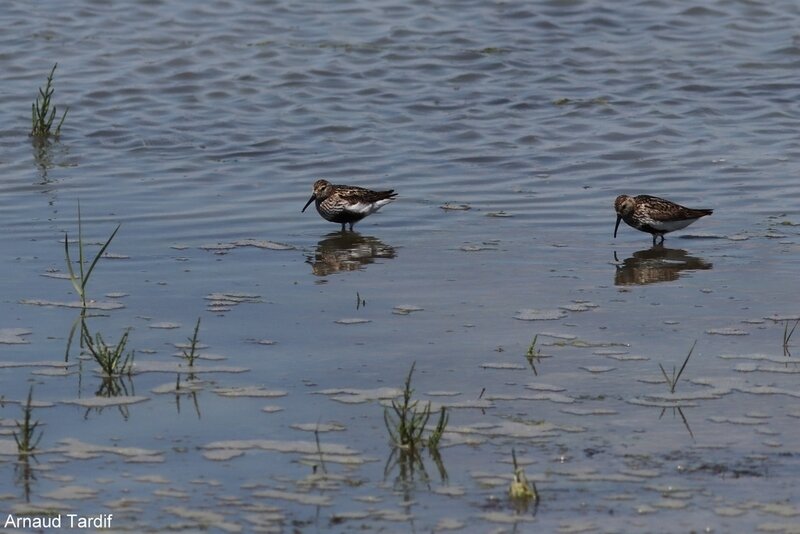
[300, 180, 397, 232]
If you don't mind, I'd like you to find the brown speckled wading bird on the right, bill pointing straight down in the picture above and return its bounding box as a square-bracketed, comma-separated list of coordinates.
[614, 195, 714, 245]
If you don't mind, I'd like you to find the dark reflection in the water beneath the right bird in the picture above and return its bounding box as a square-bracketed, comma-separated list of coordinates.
[614, 245, 714, 286]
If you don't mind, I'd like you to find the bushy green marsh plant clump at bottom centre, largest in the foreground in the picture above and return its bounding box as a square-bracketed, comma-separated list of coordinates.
[383, 362, 449, 451]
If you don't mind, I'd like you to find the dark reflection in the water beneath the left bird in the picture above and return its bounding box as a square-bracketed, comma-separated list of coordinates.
[306, 231, 396, 276]
